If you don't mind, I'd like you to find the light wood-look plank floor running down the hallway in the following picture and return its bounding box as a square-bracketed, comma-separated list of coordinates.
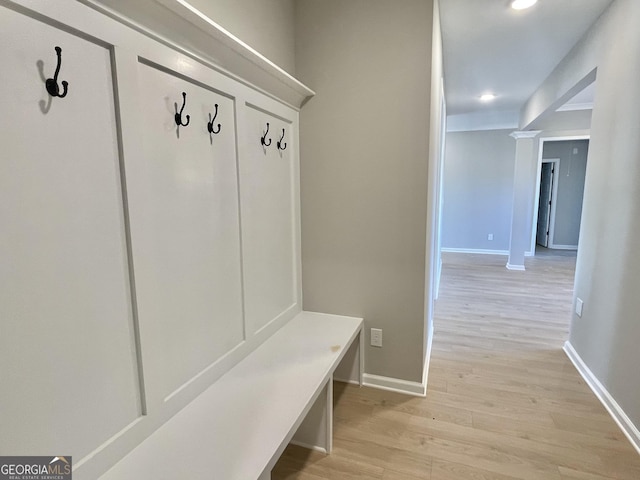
[272, 254, 640, 480]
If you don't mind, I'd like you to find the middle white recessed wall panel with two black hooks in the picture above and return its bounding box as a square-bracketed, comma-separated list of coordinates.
[127, 63, 244, 398]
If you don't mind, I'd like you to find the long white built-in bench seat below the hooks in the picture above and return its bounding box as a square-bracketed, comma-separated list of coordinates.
[101, 312, 363, 480]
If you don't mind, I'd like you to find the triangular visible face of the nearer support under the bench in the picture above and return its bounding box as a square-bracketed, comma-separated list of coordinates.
[291, 377, 333, 453]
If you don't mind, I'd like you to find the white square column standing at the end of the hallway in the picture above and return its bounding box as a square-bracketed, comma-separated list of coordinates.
[507, 130, 540, 270]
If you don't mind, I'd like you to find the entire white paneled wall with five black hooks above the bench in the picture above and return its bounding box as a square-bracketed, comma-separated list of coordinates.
[0, 0, 312, 479]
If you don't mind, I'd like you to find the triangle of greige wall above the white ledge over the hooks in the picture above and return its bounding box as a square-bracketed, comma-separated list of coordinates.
[189, 0, 295, 75]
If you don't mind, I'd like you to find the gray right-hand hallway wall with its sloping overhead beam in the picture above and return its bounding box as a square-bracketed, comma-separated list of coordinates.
[521, 0, 640, 427]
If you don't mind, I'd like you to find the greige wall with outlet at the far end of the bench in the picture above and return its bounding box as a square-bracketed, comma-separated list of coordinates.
[295, 0, 440, 381]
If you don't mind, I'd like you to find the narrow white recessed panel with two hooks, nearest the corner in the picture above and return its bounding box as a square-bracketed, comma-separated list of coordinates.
[240, 104, 298, 335]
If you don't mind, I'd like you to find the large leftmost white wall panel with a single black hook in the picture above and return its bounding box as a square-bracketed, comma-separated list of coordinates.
[0, 8, 141, 459]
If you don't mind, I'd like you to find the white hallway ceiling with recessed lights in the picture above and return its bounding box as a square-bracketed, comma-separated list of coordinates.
[440, 0, 612, 115]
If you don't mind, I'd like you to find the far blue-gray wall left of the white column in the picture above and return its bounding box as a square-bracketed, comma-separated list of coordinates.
[442, 130, 516, 251]
